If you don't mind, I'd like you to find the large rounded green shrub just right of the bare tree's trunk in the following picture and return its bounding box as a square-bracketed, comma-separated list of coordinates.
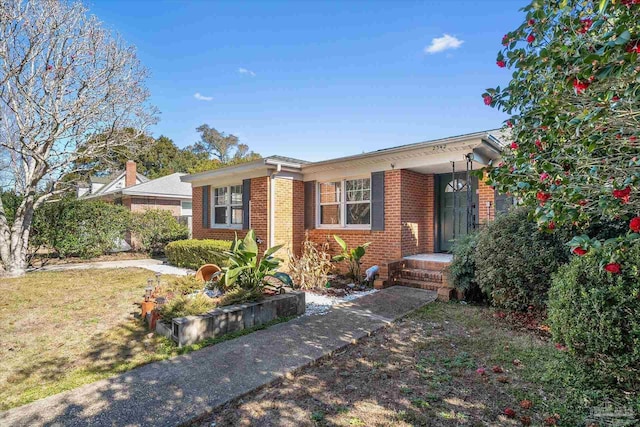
[32, 198, 130, 258]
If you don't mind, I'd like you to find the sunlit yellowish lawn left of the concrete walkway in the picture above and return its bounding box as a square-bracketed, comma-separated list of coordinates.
[0, 269, 175, 410]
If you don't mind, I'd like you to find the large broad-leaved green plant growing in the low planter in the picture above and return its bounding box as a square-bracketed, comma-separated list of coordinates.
[221, 230, 293, 291]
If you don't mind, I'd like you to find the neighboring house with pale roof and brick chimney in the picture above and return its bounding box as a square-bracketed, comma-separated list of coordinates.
[78, 161, 192, 218]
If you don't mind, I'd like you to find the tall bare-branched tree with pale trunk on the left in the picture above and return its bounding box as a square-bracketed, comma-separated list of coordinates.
[0, 0, 156, 276]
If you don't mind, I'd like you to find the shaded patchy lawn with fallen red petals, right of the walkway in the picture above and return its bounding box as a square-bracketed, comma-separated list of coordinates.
[202, 303, 602, 426]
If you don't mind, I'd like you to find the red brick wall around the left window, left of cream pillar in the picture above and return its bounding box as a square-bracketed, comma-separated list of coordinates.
[192, 176, 269, 251]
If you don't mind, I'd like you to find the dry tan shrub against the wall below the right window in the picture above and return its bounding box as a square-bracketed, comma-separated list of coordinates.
[289, 236, 332, 289]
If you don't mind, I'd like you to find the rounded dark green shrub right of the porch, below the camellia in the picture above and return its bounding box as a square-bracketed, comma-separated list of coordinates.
[475, 209, 569, 310]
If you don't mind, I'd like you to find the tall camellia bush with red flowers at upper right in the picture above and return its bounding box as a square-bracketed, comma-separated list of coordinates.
[483, 0, 640, 270]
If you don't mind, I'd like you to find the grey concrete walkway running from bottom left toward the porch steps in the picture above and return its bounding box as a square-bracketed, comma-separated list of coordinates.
[0, 287, 436, 426]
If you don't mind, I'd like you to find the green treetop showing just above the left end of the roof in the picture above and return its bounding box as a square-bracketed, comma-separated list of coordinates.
[192, 124, 260, 165]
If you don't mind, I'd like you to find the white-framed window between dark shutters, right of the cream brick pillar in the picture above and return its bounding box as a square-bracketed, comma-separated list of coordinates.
[318, 178, 371, 229]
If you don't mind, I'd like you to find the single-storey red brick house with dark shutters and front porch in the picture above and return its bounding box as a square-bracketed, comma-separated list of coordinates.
[182, 131, 505, 299]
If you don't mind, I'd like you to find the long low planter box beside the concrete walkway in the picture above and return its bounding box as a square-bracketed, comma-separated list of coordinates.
[156, 291, 305, 347]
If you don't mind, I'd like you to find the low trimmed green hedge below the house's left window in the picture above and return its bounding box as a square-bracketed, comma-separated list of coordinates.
[164, 239, 231, 270]
